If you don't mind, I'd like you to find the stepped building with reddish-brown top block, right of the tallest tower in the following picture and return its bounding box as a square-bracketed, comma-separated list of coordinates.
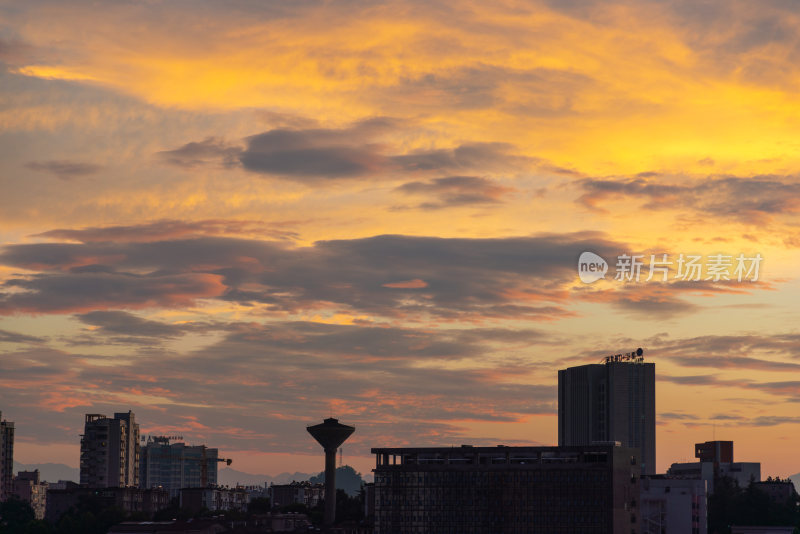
[667, 441, 761, 495]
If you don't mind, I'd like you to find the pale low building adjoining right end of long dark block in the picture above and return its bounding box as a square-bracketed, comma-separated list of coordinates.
[639, 475, 708, 534]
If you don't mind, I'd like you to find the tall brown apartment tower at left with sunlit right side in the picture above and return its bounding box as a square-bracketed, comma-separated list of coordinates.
[81, 411, 140, 488]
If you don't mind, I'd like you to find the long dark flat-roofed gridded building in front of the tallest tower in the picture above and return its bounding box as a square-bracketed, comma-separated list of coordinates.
[372, 444, 641, 534]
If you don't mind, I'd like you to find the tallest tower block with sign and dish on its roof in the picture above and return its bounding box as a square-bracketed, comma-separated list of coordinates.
[558, 357, 656, 474]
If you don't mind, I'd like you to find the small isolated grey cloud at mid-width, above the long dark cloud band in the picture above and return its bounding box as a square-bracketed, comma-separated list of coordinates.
[396, 176, 512, 210]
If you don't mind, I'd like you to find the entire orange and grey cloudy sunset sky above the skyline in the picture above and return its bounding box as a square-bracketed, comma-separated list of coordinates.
[0, 0, 800, 477]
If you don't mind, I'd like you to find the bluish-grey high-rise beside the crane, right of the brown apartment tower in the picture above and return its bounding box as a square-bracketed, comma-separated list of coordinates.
[139, 436, 220, 497]
